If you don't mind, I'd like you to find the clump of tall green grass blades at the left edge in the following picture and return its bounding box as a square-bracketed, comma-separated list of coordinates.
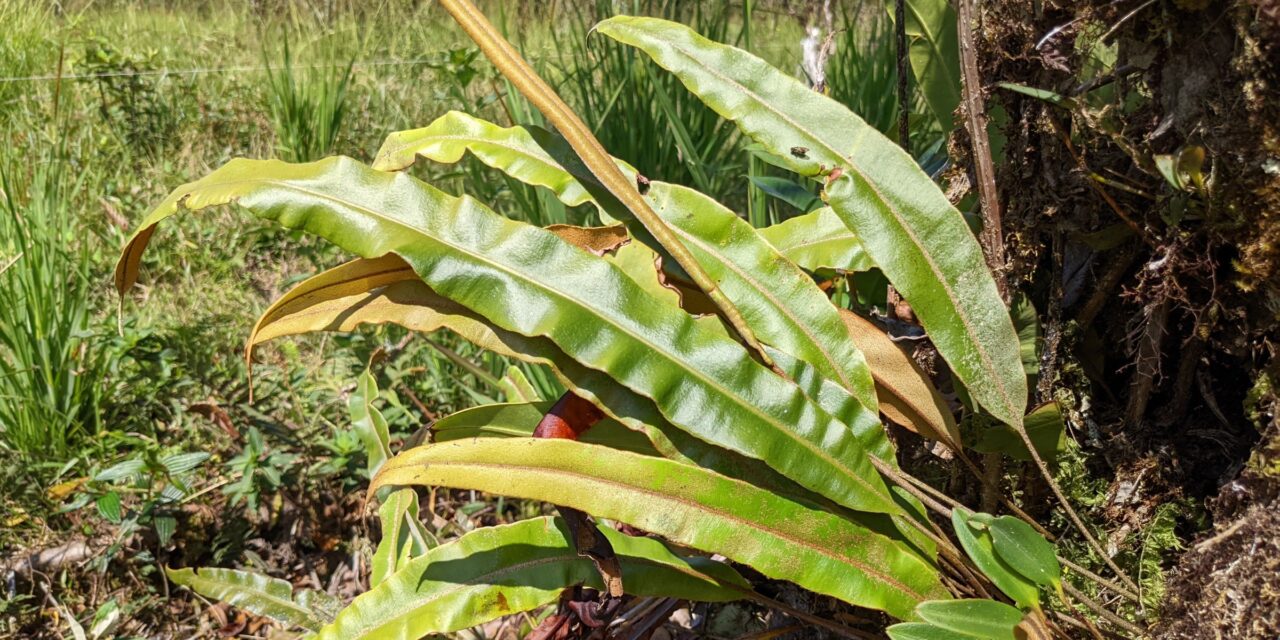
[0, 144, 104, 460]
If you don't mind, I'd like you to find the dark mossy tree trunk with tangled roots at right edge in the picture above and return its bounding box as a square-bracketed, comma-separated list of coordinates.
[952, 0, 1280, 639]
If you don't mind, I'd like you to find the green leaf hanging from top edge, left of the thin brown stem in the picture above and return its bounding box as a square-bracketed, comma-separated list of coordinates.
[890, 0, 960, 132]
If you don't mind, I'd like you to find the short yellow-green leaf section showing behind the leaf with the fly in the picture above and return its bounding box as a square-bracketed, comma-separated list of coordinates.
[760, 206, 876, 273]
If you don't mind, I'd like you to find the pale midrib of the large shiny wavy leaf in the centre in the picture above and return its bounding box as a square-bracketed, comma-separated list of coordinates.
[189, 178, 892, 503]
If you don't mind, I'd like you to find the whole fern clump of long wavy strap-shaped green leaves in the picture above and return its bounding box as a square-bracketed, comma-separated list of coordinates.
[115, 0, 1126, 639]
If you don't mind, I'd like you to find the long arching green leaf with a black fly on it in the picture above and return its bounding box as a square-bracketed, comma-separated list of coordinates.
[596, 17, 1027, 426]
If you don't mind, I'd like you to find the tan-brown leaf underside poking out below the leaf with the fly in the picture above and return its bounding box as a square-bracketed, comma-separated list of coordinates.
[840, 310, 960, 451]
